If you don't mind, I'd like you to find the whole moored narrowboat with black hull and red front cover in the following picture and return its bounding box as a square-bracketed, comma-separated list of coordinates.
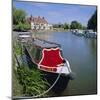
[19, 34, 73, 93]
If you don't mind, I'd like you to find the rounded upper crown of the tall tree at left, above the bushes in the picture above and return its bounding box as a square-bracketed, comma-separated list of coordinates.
[13, 7, 26, 25]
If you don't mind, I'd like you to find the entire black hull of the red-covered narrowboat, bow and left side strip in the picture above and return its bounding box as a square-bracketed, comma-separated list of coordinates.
[25, 47, 71, 93]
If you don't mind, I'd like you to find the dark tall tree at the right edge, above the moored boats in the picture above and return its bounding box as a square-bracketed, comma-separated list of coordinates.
[87, 10, 97, 31]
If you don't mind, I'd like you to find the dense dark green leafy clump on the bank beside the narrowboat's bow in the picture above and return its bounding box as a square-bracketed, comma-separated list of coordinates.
[17, 66, 49, 96]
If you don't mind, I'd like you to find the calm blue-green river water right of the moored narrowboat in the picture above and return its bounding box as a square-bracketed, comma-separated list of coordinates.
[35, 32, 97, 96]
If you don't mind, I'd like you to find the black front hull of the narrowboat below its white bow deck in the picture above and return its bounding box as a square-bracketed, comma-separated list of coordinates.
[41, 71, 70, 94]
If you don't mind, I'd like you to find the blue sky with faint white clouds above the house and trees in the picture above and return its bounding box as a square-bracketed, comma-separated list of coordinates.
[13, 0, 96, 26]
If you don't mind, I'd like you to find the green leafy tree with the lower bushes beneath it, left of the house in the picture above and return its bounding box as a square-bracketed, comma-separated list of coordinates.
[13, 7, 31, 31]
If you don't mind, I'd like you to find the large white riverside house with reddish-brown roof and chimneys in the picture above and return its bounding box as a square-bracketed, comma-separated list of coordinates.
[27, 15, 53, 30]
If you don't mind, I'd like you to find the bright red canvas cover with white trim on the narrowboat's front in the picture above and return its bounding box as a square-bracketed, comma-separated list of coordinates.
[39, 48, 63, 68]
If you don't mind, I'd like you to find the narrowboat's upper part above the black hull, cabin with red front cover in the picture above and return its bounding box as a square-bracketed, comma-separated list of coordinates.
[25, 38, 71, 74]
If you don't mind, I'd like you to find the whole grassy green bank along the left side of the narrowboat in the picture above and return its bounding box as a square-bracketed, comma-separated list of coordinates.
[12, 41, 49, 97]
